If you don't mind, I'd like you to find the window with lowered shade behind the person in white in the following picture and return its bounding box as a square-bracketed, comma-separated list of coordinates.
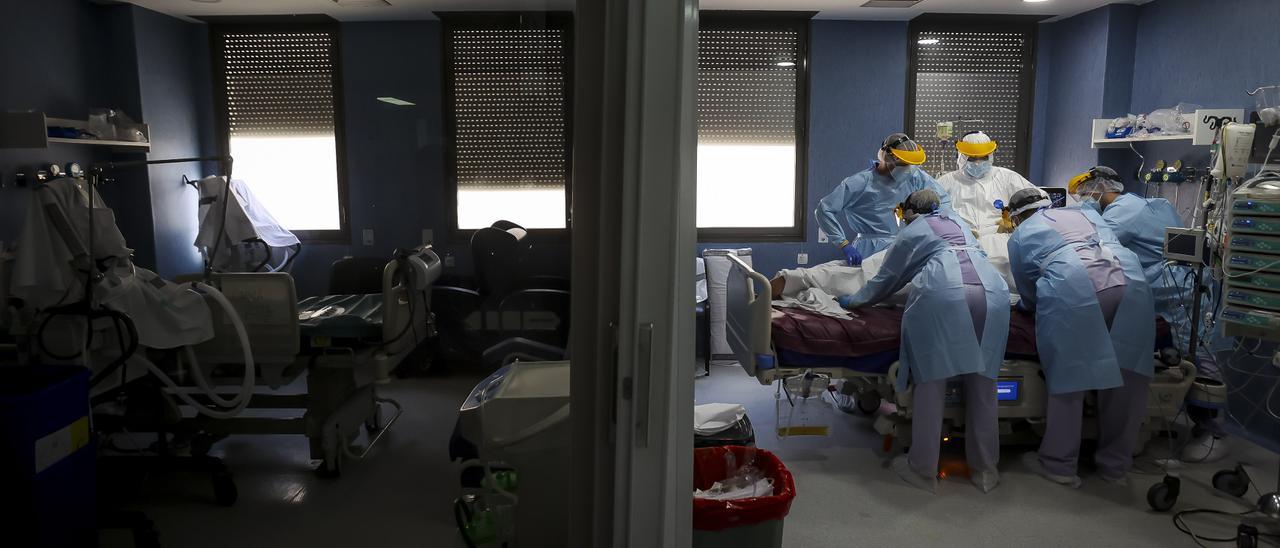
[906, 15, 1036, 177]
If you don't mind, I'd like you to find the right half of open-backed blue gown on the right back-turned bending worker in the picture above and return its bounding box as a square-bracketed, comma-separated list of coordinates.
[1082, 209, 1156, 378]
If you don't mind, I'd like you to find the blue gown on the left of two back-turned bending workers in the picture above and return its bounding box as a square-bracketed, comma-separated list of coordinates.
[850, 211, 1009, 391]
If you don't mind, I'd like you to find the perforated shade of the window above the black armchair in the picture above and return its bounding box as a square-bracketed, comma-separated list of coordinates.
[445, 23, 570, 191]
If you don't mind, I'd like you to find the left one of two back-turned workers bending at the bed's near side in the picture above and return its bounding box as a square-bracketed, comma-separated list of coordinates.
[838, 188, 1009, 493]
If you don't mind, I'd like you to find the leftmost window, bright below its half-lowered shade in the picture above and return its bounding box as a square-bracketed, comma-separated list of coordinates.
[212, 23, 347, 241]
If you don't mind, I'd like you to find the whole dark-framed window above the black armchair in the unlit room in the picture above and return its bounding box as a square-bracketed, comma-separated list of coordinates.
[440, 13, 572, 230]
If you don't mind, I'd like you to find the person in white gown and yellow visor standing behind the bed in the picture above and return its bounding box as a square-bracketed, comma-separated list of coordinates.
[938, 132, 1036, 289]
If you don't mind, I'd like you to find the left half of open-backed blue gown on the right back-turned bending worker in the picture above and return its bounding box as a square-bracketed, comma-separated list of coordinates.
[1009, 207, 1131, 394]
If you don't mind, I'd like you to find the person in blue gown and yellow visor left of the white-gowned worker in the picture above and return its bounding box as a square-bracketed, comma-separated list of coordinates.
[814, 133, 951, 266]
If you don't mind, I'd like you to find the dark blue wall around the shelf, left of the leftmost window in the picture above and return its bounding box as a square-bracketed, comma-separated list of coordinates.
[0, 0, 212, 277]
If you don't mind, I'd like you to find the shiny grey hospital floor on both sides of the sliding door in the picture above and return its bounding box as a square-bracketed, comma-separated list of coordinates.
[102, 366, 1276, 548]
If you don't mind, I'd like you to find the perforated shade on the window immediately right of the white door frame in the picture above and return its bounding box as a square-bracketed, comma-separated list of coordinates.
[698, 28, 804, 145]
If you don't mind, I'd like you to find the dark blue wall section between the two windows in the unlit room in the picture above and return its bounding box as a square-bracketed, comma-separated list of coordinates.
[285, 22, 445, 296]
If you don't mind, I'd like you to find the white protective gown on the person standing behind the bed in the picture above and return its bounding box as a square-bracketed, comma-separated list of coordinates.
[938, 165, 1036, 287]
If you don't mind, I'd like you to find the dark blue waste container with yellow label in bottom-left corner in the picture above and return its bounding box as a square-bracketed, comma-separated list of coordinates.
[0, 364, 97, 547]
